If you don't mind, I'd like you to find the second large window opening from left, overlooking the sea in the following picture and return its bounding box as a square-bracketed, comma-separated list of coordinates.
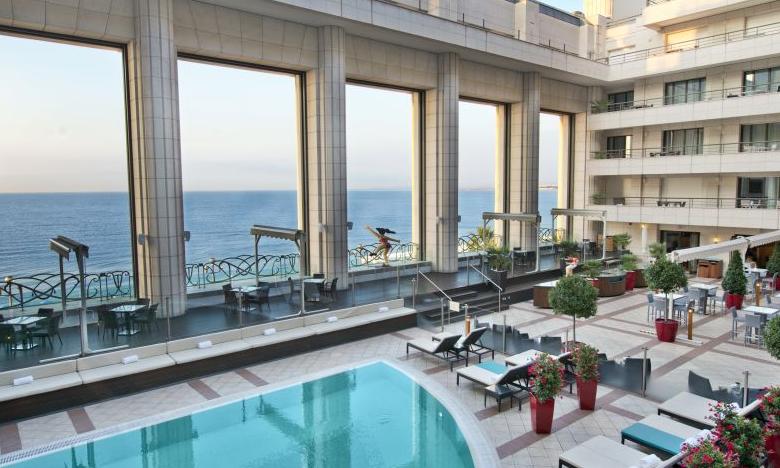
[178, 60, 298, 278]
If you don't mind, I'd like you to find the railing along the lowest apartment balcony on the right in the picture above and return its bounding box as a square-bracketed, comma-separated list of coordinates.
[591, 195, 779, 209]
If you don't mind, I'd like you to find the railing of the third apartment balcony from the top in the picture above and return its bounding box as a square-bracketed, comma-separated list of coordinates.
[590, 82, 780, 114]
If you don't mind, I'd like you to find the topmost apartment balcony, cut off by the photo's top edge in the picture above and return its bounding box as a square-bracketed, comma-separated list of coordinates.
[642, 0, 772, 29]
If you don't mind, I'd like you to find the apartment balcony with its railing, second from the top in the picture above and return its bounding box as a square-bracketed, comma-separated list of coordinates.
[599, 21, 780, 81]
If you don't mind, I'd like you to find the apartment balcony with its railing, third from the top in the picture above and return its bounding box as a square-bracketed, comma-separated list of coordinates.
[588, 83, 780, 131]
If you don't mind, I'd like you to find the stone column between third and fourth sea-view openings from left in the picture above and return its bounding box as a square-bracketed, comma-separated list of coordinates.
[425, 53, 460, 273]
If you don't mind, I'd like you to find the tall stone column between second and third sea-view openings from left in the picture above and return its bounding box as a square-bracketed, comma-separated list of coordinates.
[305, 26, 348, 287]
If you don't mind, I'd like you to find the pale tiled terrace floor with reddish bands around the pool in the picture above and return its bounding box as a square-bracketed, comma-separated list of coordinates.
[0, 280, 780, 467]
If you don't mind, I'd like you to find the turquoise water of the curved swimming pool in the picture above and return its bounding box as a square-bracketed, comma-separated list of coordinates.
[6, 363, 474, 468]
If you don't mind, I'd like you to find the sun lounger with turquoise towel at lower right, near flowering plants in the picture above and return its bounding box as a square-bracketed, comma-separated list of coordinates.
[620, 415, 701, 455]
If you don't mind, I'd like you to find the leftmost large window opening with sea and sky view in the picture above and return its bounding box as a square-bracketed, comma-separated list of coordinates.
[0, 35, 133, 290]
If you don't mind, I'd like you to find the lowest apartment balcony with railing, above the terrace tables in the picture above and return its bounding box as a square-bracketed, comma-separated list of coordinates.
[588, 197, 780, 229]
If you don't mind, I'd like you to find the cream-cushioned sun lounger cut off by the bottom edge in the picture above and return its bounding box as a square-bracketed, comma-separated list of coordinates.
[558, 436, 682, 468]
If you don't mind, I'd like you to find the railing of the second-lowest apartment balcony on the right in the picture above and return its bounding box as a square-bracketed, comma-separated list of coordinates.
[590, 141, 780, 159]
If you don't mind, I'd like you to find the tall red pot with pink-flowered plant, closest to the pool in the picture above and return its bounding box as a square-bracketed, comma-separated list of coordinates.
[528, 353, 563, 434]
